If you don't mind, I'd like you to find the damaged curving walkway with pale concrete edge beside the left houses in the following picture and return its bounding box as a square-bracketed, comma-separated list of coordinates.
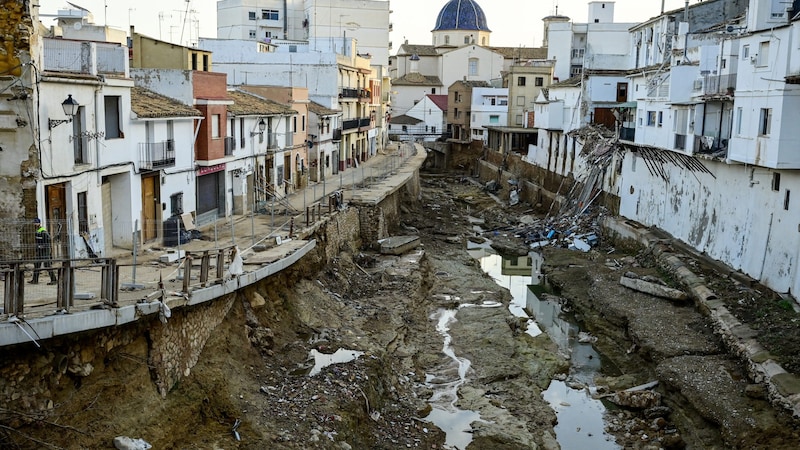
[0, 144, 426, 346]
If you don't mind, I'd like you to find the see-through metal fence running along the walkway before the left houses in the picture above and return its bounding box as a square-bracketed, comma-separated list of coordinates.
[0, 146, 413, 314]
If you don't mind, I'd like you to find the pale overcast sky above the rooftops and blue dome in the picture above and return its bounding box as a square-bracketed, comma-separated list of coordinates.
[39, 0, 698, 51]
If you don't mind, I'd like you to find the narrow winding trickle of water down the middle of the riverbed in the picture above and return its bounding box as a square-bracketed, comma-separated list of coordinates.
[425, 309, 481, 450]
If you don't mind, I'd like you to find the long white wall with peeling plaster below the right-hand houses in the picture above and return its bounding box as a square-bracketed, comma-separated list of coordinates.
[620, 153, 800, 295]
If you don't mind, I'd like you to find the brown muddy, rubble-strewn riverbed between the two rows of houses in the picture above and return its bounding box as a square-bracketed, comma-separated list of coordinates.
[6, 177, 800, 449]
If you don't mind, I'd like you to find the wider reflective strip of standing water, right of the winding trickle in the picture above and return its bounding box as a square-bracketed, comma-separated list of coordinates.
[470, 246, 621, 450]
